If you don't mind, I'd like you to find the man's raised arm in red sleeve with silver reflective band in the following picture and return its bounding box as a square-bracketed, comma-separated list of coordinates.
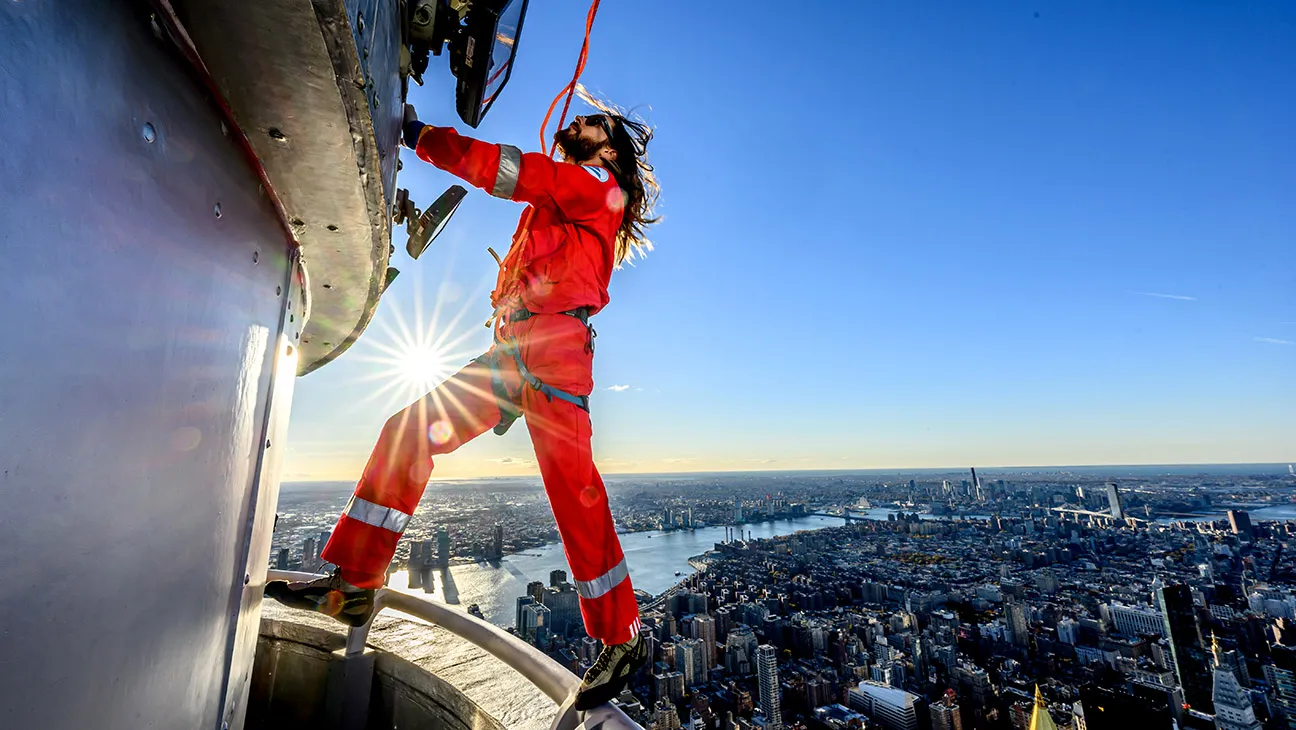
[403, 110, 608, 220]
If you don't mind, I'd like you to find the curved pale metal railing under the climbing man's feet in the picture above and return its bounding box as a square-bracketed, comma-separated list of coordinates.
[266, 569, 643, 730]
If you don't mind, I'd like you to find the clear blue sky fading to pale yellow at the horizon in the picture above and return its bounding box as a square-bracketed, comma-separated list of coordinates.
[284, 1, 1296, 480]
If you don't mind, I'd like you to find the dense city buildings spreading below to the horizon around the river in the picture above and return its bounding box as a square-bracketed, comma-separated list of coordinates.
[265, 472, 1296, 730]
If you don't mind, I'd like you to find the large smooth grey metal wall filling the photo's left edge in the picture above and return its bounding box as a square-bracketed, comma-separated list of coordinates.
[0, 0, 292, 729]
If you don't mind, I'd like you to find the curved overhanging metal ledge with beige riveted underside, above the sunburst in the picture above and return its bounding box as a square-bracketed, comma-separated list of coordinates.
[171, 0, 400, 373]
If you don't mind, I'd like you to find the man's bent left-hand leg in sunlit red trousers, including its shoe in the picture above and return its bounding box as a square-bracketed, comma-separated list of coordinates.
[266, 353, 502, 626]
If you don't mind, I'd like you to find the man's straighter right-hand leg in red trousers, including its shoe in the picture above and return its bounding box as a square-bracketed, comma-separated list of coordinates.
[522, 388, 648, 711]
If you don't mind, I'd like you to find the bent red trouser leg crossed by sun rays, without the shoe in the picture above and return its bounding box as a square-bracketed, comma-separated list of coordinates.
[320, 360, 517, 587]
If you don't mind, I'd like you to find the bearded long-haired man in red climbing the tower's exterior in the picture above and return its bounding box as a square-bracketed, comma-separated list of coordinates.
[266, 101, 657, 709]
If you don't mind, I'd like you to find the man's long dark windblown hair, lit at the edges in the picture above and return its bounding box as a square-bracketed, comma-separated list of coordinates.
[577, 86, 661, 266]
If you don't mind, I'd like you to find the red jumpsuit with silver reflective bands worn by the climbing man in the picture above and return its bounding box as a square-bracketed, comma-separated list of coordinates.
[323, 127, 639, 644]
